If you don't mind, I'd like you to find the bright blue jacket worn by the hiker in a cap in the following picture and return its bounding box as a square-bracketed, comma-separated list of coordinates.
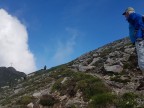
[127, 13, 144, 43]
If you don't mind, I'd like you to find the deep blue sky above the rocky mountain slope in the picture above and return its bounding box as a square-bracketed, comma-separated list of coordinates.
[0, 0, 144, 69]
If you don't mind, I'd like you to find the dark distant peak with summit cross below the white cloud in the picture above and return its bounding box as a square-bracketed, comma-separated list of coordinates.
[0, 67, 26, 88]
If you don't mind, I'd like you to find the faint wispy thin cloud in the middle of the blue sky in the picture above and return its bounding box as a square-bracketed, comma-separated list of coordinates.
[53, 28, 79, 65]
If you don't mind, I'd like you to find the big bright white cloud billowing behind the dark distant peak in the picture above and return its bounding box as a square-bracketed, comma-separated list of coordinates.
[0, 9, 36, 73]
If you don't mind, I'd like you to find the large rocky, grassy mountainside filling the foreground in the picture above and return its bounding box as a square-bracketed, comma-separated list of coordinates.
[0, 38, 144, 108]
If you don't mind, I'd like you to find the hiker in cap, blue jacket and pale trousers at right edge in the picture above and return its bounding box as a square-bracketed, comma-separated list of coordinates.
[122, 7, 144, 75]
